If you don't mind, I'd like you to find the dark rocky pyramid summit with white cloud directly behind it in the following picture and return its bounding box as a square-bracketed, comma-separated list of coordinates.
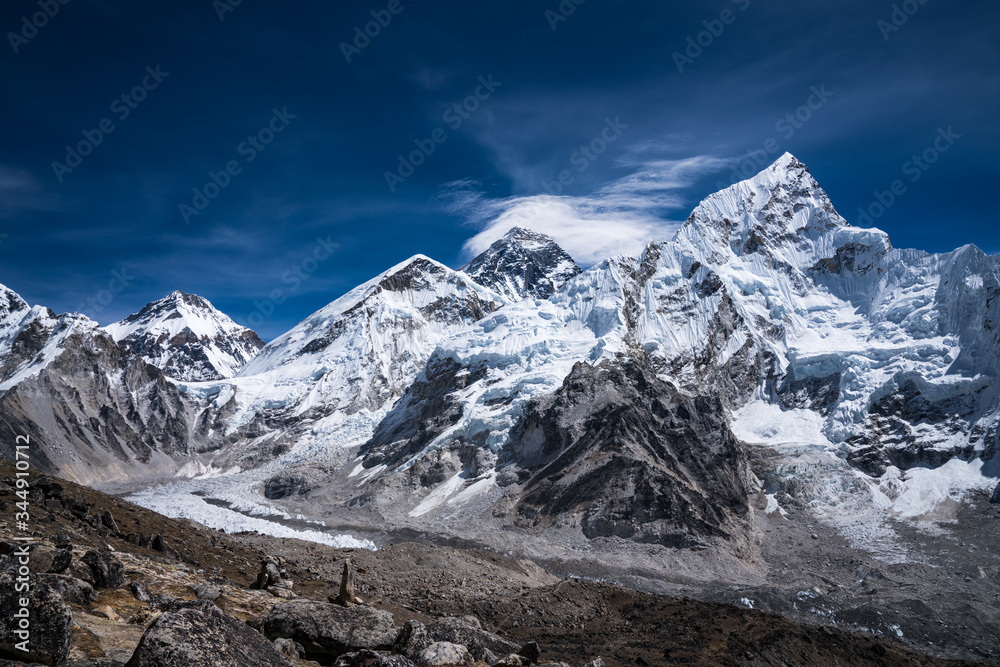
[462, 227, 583, 301]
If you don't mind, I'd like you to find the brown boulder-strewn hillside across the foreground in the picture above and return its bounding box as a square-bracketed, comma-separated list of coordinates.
[0, 462, 976, 667]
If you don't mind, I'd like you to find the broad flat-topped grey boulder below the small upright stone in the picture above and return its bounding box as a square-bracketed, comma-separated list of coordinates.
[264, 600, 399, 662]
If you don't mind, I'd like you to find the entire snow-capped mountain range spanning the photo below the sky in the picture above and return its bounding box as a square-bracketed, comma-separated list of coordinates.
[0, 154, 1000, 561]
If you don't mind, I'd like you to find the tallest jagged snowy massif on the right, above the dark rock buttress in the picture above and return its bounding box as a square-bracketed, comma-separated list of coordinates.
[346, 154, 1000, 552]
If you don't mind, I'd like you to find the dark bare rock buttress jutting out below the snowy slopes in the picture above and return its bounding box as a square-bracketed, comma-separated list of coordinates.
[508, 360, 751, 548]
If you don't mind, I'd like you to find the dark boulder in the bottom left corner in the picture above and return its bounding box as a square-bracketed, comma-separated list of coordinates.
[0, 556, 73, 665]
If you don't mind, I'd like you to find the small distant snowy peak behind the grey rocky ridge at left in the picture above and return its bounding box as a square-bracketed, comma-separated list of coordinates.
[105, 291, 264, 382]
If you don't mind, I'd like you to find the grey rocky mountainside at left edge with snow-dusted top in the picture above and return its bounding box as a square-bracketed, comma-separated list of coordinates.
[0, 288, 211, 484]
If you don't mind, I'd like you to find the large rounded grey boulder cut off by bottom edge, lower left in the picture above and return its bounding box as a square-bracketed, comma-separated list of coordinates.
[126, 602, 292, 667]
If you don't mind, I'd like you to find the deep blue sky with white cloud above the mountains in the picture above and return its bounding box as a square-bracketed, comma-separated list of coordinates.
[0, 0, 1000, 339]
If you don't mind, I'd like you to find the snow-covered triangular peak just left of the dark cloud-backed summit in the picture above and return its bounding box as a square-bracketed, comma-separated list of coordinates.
[165, 255, 505, 469]
